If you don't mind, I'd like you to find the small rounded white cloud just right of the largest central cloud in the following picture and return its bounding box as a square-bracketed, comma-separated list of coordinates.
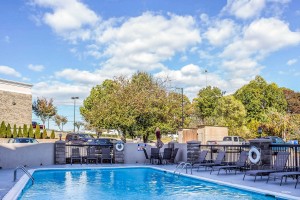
[204, 19, 238, 46]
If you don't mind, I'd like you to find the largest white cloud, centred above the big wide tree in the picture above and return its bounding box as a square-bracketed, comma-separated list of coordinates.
[98, 13, 201, 71]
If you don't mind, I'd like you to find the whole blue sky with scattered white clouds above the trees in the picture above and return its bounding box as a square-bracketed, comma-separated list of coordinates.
[0, 0, 300, 130]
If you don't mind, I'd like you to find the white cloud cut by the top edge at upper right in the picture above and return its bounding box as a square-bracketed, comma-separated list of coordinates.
[223, 0, 265, 19]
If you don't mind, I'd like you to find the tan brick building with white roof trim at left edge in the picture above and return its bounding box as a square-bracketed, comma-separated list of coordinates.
[0, 79, 32, 127]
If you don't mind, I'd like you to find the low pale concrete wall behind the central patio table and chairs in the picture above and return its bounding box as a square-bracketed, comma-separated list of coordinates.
[124, 143, 187, 164]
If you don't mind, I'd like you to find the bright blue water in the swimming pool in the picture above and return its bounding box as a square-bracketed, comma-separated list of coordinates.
[19, 168, 274, 200]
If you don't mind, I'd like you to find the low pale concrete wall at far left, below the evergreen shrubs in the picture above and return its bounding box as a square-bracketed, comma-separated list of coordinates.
[0, 143, 54, 169]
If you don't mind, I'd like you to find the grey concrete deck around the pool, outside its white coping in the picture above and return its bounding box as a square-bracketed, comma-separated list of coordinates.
[0, 164, 300, 200]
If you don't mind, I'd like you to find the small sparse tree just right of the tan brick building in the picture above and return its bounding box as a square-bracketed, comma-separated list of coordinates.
[32, 97, 57, 129]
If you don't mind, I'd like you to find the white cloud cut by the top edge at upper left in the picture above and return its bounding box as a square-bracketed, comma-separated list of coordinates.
[32, 0, 100, 40]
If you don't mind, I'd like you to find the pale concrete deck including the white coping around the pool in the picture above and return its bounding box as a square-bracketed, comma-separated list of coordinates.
[0, 164, 300, 200]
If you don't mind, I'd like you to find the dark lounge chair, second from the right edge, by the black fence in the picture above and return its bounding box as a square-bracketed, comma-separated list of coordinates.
[243, 152, 290, 182]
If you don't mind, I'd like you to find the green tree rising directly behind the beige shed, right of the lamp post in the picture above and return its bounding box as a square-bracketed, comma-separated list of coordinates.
[194, 86, 222, 123]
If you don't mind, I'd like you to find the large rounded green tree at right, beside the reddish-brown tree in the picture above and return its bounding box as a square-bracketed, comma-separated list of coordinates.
[234, 76, 287, 122]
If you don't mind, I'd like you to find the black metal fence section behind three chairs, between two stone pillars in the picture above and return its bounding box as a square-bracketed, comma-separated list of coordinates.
[66, 144, 114, 164]
